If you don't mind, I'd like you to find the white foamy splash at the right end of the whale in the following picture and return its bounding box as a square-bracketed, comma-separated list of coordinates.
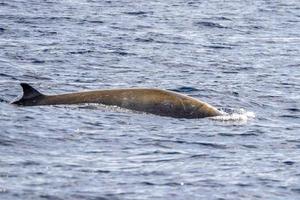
[210, 108, 255, 122]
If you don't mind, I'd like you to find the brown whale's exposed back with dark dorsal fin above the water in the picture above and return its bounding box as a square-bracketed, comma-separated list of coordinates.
[12, 83, 221, 118]
